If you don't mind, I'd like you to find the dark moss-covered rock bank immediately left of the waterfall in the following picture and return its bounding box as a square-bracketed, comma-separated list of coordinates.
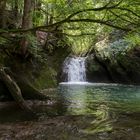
[0, 42, 70, 90]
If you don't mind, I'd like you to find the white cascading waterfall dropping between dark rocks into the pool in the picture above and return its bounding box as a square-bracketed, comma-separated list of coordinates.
[63, 57, 86, 82]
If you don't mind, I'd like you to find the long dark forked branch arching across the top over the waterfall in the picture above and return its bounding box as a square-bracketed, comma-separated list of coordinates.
[0, 1, 140, 35]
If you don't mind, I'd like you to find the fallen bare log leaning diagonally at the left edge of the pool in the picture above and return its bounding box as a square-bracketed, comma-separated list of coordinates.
[0, 68, 32, 112]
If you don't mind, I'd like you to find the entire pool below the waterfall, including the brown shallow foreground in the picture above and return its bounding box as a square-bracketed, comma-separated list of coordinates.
[0, 83, 140, 140]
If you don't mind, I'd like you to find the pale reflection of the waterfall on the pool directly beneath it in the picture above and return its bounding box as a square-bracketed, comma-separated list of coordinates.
[59, 85, 88, 115]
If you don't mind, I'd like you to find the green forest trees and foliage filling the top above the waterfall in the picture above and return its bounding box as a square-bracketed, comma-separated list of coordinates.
[0, 0, 140, 57]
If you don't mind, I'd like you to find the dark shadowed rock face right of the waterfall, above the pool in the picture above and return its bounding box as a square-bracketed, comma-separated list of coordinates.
[87, 47, 140, 84]
